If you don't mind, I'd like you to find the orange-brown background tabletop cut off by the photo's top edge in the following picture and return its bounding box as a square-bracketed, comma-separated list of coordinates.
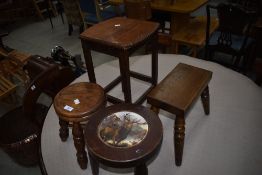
[109, 0, 207, 13]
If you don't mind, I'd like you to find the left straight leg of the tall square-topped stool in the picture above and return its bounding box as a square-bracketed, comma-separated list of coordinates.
[82, 41, 96, 83]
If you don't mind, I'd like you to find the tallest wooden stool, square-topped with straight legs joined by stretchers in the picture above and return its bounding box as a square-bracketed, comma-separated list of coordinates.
[80, 17, 159, 104]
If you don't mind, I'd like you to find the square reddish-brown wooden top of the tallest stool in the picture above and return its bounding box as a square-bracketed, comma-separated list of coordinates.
[80, 17, 159, 49]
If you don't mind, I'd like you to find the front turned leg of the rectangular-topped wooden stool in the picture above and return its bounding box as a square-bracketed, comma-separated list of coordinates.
[174, 115, 185, 166]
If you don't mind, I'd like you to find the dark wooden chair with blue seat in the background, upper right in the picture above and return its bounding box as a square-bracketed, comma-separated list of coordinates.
[205, 3, 255, 70]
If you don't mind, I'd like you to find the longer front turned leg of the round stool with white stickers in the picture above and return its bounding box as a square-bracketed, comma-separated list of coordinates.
[72, 122, 88, 169]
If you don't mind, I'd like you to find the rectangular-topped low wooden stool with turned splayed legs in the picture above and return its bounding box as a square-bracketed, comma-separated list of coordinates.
[147, 63, 212, 166]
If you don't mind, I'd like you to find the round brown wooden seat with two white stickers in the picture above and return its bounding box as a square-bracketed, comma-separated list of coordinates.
[54, 82, 105, 121]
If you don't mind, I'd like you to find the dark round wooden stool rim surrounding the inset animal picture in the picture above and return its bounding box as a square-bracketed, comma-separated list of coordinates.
[85, 104, 163, 168]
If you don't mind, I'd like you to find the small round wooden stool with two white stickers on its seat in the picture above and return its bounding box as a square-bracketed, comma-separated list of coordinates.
[54, 82, 106, 169]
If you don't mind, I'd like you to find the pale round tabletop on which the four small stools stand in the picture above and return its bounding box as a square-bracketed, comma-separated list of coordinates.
[41, 54, 262, 175]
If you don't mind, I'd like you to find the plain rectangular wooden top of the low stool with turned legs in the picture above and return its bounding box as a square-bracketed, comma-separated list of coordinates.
[147, 63, 212, 115]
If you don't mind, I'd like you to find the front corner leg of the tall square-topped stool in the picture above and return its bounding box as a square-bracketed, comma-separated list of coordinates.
[119, 52, 132, 103]
